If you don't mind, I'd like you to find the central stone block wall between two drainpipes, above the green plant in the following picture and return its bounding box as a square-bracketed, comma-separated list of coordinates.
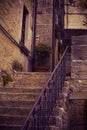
[36, 0, 53, 45]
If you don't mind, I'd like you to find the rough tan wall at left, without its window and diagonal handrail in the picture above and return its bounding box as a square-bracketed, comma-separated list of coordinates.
[0, 0, 33, 71]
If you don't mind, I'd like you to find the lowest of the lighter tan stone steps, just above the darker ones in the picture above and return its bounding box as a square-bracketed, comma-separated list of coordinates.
[0, 92, 38, 100]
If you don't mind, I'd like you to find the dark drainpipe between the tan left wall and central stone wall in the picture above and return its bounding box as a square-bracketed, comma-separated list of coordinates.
[32, 0, 37, 71]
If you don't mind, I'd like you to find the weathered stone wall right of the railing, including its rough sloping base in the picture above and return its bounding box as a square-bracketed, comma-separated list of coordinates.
[46, 36, 87, 130]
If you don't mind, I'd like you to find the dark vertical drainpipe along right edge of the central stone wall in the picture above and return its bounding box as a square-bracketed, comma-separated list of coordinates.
[51, 0, 55, 71]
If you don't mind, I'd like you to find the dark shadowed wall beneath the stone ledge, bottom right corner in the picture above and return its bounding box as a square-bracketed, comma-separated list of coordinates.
[69, 100, 86, 130]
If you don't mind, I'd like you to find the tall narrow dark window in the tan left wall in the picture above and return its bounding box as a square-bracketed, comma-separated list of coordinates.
[21, 6, 29, 45]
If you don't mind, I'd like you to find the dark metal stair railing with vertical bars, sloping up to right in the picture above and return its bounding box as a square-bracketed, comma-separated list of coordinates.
[21, 47, 68, 130]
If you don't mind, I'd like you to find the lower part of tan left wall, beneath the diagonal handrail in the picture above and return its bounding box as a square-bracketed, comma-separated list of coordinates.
[0, 31, 28, 72]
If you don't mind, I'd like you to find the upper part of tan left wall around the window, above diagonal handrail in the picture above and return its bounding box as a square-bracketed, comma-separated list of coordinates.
[0, 0, 33, 48]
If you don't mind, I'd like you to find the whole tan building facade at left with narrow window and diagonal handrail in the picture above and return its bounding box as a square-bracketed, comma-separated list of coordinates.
[0, 0, 33, 72]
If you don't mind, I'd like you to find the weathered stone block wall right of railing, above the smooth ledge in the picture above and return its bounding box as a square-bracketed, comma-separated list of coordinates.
[70, 36, 87, 92]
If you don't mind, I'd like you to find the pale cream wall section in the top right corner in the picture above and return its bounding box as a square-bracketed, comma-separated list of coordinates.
[65, 0, 87, 29]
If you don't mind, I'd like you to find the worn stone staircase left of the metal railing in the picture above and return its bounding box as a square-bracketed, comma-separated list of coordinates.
[0, 72, 50, 130]
